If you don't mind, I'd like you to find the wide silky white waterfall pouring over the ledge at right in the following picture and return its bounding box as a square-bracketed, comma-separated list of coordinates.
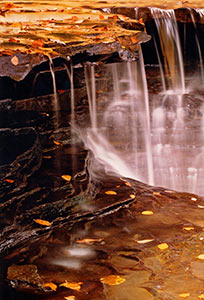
[75, 8, 204, 194]
